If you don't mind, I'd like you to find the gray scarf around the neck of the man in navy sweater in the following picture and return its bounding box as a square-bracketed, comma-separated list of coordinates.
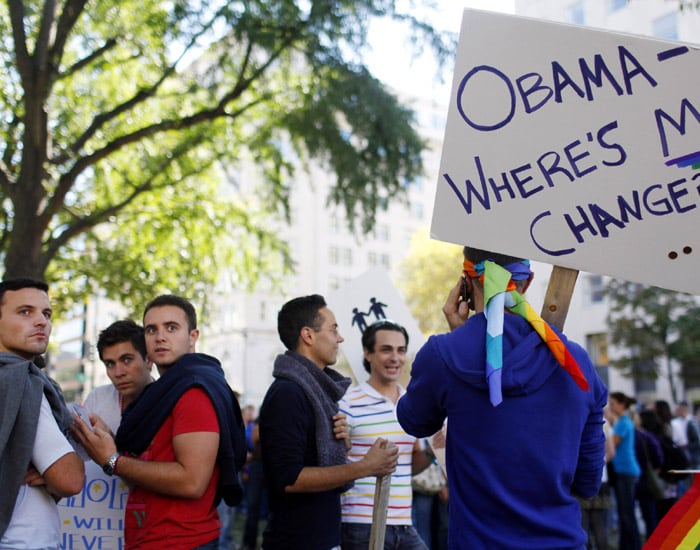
[272, 351, 352, 466]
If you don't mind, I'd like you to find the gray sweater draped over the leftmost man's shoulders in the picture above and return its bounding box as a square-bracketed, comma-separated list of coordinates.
[0, 352, 72, 537]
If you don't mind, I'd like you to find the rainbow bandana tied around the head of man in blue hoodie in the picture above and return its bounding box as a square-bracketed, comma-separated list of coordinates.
[464, 260, 588, 407]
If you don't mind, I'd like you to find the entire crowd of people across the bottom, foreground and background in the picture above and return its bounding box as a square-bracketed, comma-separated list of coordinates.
[0, 247, 700, 550]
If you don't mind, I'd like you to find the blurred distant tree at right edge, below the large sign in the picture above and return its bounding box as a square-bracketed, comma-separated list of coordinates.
[606, 279, 700, 401]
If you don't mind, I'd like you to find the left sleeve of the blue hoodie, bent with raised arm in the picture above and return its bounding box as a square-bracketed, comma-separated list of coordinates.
[396, 336, 448, 437]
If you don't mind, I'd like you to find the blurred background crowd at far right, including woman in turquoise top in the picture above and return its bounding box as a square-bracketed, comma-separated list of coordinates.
[582, 392, 700, 550]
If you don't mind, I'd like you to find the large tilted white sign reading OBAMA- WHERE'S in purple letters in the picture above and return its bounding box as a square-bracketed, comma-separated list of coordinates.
[431, 10, 700, 294]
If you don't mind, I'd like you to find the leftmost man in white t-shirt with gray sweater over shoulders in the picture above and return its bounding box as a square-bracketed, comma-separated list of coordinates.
[0, 279, 84, 549]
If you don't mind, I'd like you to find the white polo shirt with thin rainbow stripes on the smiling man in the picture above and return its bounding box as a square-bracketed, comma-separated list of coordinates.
[340, 382, 416, 525]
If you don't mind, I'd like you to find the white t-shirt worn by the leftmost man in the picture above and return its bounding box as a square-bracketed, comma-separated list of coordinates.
[0, 396, 73, 550]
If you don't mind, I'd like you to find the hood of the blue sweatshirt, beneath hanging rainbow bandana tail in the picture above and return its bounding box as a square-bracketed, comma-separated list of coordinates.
[438, 313, 569, 399]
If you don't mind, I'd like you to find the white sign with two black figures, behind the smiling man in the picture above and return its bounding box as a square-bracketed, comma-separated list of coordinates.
[327, 268, 425, 382]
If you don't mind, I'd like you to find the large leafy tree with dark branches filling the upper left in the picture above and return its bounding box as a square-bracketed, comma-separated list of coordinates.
[0, 0, 455, 316]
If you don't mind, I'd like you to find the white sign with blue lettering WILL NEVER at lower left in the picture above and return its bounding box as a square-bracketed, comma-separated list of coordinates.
[58, 460, 129, 550]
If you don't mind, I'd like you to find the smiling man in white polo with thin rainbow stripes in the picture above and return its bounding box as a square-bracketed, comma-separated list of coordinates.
[340, 319, 430, 550]
